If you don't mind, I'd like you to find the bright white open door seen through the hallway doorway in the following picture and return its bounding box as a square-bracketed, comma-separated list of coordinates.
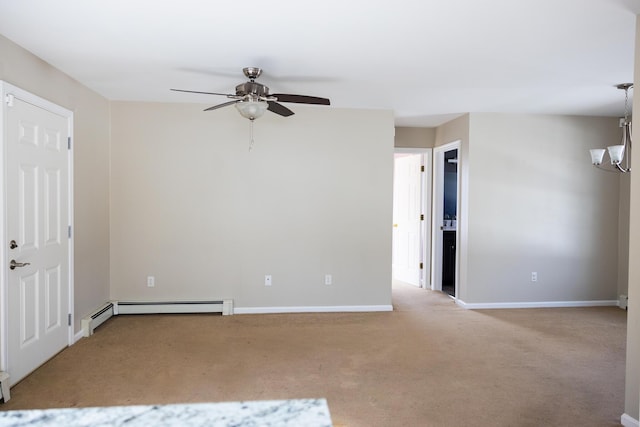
[392, 154, 422, 286]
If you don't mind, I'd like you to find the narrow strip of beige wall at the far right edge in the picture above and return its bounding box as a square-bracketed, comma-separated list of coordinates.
[624, 16, 640, 420]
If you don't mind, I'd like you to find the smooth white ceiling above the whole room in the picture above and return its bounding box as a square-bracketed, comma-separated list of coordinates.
[0, 0, 640, 127]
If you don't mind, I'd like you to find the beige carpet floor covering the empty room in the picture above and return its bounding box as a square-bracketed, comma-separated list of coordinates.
[0, 283, 626, 427]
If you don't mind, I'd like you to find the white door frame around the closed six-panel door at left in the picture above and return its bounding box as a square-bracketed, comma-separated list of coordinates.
[0, 80, 75, 372]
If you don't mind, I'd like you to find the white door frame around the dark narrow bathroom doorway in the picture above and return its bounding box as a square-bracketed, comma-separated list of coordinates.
[431, 140, 462, 300]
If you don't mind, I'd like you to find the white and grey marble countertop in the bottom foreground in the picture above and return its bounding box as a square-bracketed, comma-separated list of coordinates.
[0, 399, 332, 427]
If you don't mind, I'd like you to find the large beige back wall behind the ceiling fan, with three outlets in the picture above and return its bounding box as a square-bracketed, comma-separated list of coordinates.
[111, 102, 394, 308]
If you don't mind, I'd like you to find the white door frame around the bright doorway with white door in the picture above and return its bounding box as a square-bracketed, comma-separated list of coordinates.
[393, 148, 433, 289]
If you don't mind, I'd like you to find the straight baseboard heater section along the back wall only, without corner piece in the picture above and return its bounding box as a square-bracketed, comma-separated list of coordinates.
[116, 300, 233, 315]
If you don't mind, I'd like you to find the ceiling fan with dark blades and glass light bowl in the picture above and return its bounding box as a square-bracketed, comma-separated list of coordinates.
[171, 67, 330, 121]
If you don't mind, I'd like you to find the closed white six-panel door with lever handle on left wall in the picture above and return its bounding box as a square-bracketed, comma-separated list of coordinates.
[5, 97, 70, 384]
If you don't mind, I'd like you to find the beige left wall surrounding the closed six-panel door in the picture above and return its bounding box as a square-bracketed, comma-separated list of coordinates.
[0, 36, 109, 332]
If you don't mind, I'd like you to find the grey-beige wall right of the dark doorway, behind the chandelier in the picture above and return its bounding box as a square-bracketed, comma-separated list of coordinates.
[464, 113, 620, 303]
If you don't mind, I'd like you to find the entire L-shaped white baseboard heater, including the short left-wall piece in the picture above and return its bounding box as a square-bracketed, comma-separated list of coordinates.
[82, 300, 233, 337]
